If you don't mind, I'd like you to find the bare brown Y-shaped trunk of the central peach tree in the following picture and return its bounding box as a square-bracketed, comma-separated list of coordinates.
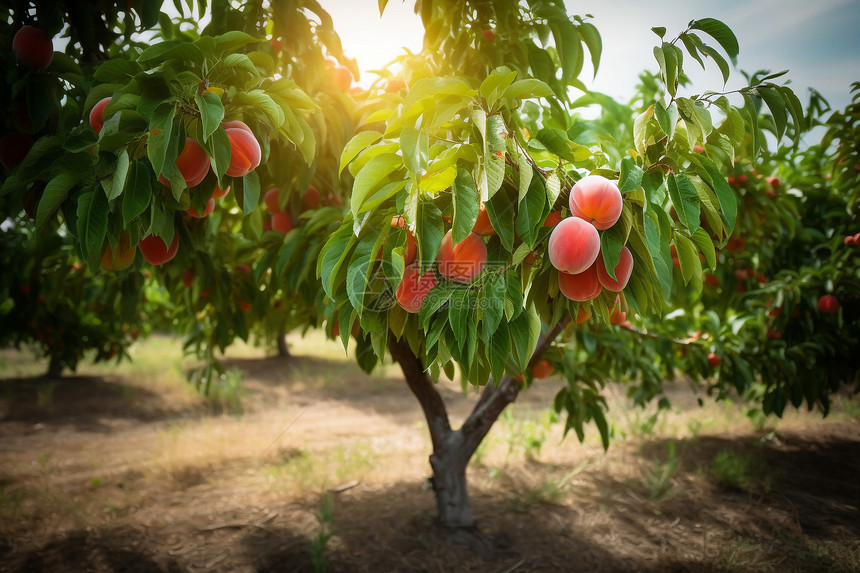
[388, 320, 568, 532]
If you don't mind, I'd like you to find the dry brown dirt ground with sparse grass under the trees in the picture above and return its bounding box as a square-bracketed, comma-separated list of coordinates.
[0, 336, 860, 573]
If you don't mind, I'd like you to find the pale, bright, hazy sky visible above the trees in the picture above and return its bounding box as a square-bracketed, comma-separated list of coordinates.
[328, 0, 860, 109]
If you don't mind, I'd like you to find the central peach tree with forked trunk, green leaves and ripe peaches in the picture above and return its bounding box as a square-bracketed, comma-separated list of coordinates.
[318, 1, 802, 528]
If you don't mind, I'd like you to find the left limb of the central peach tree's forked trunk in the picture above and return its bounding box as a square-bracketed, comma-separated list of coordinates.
[388, 334, 452, 452]
